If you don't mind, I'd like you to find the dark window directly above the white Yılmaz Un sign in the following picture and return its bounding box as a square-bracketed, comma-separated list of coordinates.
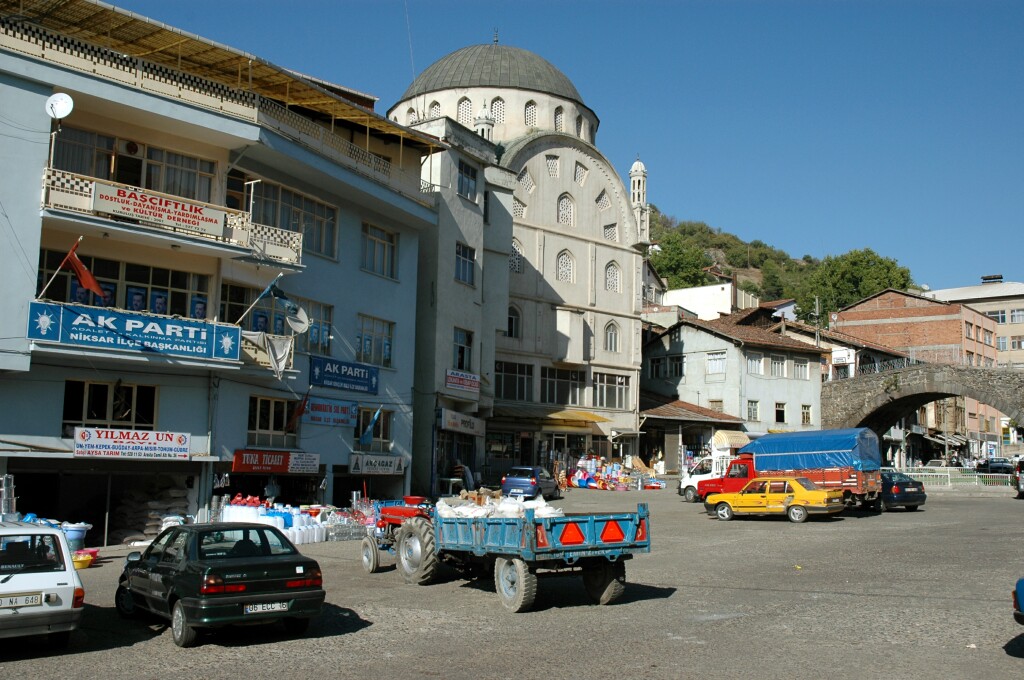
[60, 380, 157, 437]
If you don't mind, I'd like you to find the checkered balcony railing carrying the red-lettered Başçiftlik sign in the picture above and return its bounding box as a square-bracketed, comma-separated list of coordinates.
[42, 168, 302, 265]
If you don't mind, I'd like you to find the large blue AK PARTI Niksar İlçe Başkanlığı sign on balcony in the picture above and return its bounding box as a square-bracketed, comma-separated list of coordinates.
[27, 300, 241, 362]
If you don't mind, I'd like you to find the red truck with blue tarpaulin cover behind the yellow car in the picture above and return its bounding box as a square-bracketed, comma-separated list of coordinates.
[697, 427, 882, 508]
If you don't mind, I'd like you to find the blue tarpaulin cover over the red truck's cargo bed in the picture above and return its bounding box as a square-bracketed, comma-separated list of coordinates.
[739, 427, 882, 473]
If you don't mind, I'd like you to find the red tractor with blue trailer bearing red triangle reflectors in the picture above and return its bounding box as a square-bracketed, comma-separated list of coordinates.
[361, 503, 650, 611]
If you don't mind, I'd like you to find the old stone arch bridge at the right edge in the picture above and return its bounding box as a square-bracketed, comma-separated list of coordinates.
[821, 364, 1024, 436]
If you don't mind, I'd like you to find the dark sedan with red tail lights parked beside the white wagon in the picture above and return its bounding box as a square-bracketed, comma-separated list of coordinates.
[114, 522, 325, 647]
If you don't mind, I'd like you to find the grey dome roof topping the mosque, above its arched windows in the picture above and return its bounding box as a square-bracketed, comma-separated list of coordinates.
[401, 43, 583, 103]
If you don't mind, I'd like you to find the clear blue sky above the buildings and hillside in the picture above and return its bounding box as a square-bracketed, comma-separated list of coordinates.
[113, 0, 1024, 289]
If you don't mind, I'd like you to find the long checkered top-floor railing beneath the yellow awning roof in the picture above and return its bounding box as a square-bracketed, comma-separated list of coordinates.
[0, 19, 437, 207]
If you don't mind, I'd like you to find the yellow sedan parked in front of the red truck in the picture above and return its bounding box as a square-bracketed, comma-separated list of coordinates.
[705, 477, 846, 522]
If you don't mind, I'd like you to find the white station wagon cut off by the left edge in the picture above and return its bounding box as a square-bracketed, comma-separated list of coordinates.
[0, 522, 85, 647]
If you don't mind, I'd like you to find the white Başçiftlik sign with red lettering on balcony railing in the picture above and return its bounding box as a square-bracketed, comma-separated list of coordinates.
[92, 182, 226, 237]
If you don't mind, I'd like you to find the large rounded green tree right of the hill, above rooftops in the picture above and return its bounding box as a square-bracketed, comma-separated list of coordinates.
[794, 248, 913, 321]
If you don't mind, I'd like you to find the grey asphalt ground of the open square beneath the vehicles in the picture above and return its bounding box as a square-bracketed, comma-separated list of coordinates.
[0, 487, 1024, 680]
